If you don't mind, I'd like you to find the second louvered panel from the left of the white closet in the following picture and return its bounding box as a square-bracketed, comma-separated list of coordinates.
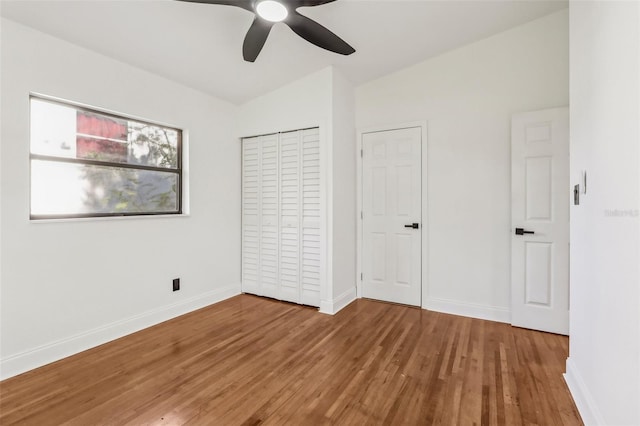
[258, 134, 280, 298]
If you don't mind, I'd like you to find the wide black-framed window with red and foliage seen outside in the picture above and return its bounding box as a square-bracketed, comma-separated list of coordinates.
[30, 96, 182, 219]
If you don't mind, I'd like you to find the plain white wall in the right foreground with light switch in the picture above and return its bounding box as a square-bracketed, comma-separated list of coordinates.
[566, 2, 640, 425]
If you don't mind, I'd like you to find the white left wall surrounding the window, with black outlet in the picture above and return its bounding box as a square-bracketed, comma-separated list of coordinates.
[0, 19, 240, 378]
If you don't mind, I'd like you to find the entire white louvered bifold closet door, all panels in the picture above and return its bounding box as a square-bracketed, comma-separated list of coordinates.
[242, 128, 321, 306]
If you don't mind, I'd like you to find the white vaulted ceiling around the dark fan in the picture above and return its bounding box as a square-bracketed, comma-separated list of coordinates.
[0, 0, 567, 103]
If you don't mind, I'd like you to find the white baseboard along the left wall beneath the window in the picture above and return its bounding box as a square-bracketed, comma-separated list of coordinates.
[0, 283, 240, 380]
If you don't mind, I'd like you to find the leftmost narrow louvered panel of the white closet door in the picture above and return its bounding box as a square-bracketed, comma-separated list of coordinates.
[242, 138, 260, 294]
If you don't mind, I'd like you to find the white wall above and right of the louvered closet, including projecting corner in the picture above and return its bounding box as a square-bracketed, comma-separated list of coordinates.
[236, 67, 356, 314]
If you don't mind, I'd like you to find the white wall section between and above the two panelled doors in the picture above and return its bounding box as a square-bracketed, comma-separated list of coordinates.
[356, 10, 569, 321]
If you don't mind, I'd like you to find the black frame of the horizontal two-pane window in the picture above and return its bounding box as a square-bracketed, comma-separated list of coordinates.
[29, 93, 183, 221]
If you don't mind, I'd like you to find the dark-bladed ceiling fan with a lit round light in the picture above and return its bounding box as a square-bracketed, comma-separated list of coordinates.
[178, 0, 355, 62]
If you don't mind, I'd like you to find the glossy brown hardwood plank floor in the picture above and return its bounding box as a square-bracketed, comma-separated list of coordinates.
[0, 295, 582, 426]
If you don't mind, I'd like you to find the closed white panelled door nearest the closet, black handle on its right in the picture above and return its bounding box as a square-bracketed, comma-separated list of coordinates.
[362, 127, 422, 306]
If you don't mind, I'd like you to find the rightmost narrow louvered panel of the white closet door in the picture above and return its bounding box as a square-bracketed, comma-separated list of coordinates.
[300, 128, 321, 306]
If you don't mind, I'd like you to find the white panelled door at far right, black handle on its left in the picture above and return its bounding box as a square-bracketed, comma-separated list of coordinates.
[511, 108, 571, 334]
